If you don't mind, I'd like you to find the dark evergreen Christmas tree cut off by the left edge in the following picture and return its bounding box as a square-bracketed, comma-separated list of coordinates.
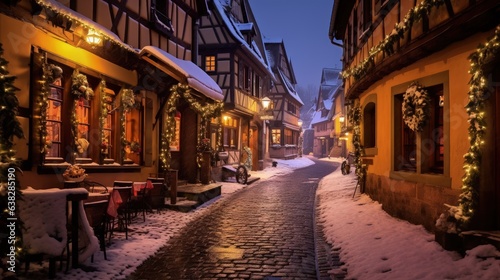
[0, 43, 24, 278]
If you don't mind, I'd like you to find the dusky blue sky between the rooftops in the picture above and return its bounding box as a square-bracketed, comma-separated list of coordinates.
[249, 0, 342, 87]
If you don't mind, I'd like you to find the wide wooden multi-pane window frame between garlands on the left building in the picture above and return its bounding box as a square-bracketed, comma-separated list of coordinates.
[35, 51, 141, 171]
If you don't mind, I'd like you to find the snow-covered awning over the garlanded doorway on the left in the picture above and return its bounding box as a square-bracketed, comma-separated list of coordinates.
[139, 46, 224, 101]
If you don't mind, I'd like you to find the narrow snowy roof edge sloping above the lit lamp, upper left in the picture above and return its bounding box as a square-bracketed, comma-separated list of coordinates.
[36, 0, 137, 52]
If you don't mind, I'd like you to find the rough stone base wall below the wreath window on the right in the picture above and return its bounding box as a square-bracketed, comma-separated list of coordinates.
[365, 173, 459, 232]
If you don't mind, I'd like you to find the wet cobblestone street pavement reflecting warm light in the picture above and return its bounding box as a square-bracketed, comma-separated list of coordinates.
[129, 162, 334, 280]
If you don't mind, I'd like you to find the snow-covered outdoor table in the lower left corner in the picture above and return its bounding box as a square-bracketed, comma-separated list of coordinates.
[19, 187, 99, 274]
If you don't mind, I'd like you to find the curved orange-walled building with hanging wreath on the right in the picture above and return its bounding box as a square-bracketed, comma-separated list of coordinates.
[329, 0, 500, 247]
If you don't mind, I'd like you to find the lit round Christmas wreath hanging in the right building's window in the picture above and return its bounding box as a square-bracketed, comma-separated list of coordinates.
[402, 83, 430, 131]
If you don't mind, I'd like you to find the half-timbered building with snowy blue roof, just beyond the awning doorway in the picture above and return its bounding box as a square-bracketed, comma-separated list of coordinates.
[198, 0, 274, 170]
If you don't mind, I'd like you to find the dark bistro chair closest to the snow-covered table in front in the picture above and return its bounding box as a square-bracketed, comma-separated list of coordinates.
[83, 200, 109, 262]
